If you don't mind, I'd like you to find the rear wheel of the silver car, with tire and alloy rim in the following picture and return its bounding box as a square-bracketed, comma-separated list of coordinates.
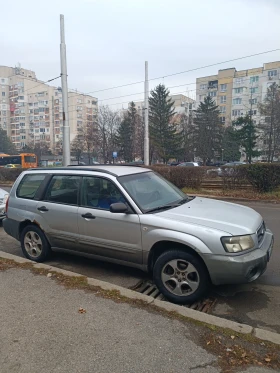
[20, 225, 51, 262]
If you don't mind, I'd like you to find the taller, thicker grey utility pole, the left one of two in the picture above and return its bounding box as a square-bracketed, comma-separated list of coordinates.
[60, 14, 71, 166]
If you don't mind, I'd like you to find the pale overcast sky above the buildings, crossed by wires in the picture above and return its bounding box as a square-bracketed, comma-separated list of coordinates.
[0, 0, 280, 109]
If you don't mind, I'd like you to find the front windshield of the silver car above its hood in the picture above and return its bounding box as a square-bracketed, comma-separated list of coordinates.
[118, 172, 187, 212]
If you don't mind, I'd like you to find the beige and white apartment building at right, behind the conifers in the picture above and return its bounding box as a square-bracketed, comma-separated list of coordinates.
[196, 62, 280, 126]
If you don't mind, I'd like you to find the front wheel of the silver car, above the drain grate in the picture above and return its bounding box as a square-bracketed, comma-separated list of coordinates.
[153, 250, 211, 304]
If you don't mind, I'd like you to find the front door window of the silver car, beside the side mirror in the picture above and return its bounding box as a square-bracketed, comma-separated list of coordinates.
[82, 177, 126, 210]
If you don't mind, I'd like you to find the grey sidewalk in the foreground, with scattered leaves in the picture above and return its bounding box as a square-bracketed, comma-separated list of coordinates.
[0, 268, 280, 373]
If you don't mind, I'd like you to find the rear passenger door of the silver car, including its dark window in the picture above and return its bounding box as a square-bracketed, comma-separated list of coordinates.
[36, 175, 82, 250]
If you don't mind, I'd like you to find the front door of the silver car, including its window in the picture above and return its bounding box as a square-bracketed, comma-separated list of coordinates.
[78, 176, 142, 263]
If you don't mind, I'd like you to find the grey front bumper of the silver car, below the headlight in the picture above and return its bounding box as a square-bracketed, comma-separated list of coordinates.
[202, 230, 274, 285]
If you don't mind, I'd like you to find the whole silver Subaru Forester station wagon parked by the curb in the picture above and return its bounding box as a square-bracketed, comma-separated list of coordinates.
[3, 166, 273, 304]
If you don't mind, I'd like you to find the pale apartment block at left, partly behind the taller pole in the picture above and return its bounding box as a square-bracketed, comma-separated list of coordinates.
[0, 66, 98, 152]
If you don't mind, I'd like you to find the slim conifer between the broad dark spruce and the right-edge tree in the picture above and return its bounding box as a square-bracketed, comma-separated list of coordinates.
[232, 115, 260, 163]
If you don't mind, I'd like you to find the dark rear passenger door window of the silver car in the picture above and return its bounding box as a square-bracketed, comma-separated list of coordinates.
[45, 175, 81, 205]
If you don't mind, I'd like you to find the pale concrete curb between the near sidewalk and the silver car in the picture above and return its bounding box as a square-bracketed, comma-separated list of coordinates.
[0, 251, 280, 345]
